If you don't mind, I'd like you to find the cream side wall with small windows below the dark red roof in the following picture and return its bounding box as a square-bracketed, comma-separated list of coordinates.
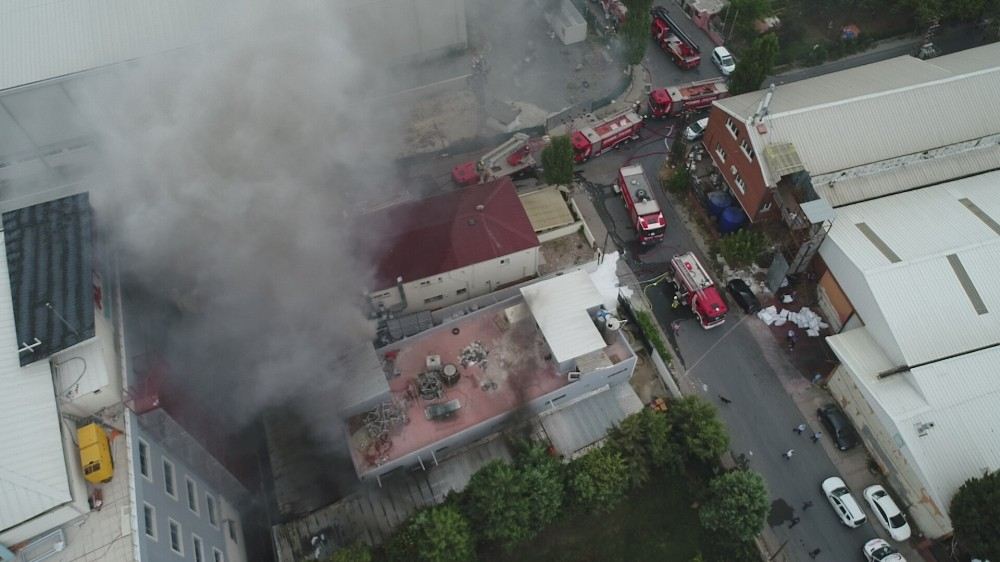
[371, 246, 538, 314]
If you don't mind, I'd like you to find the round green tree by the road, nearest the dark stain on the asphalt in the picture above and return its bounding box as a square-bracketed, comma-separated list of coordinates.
[698, 470, 770, 542]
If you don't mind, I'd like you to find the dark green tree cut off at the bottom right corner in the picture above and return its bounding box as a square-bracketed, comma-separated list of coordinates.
[948, 471, 1000, 560]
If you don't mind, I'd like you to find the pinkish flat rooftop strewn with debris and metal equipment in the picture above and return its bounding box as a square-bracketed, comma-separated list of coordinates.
[347, 296, 631, 474]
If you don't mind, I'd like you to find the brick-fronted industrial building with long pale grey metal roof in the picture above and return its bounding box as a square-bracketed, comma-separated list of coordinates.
[703, 43, 1000, 223]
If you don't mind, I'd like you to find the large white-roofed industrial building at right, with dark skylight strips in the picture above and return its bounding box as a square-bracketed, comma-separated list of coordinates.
[820, 172, 1000, 539]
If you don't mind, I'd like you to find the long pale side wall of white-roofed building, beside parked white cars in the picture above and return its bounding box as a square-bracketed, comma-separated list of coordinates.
[828, 365, 951, 538]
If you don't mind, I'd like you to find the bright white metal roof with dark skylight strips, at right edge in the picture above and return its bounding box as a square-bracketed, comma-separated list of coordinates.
[820, 172, 1000, 365]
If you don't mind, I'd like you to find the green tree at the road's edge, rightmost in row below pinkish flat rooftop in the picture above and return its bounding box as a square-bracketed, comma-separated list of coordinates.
[667, 396, 729, 463]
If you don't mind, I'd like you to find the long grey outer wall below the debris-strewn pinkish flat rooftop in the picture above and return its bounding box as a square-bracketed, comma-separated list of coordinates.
[361, 334, 636, 480]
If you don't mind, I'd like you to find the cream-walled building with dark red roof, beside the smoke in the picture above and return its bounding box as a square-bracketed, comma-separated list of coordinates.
[364, 177, 539, 315]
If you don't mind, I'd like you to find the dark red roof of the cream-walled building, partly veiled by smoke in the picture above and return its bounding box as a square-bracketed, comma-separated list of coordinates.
[364, 178, 538, 290]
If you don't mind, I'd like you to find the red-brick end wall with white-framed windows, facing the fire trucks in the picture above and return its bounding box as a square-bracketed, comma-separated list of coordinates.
[703, 105, 781, 222]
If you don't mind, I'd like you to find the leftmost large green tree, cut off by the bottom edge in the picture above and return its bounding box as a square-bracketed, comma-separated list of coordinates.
[385, 505, 476, 562]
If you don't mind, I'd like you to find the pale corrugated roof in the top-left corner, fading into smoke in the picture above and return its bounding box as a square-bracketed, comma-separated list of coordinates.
[0, 0, 223, 90]
